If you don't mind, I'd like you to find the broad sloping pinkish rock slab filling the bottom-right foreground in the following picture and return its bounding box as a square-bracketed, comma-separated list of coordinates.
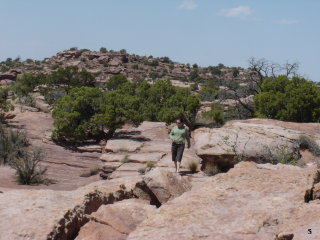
[127, 162, 320, 240]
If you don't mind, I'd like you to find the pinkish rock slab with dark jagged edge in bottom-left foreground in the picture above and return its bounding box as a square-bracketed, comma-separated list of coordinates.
[0, 177, 141, 240]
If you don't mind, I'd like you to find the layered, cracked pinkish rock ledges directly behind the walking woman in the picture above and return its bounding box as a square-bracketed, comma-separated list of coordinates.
[100, 121, 201, 179]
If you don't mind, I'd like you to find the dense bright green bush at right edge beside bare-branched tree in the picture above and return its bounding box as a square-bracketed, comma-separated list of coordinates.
[254, 76, 320, 122]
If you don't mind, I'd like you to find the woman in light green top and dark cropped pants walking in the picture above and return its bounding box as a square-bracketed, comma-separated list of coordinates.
[169, 119, 190, 172]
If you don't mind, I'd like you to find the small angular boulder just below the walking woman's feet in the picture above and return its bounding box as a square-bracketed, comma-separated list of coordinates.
[143, 167, 191, 204]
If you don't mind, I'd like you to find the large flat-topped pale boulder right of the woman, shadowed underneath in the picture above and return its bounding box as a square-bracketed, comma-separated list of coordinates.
[194, 121, 303, 170]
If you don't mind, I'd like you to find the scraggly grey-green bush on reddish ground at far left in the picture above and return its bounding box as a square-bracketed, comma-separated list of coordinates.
[10, 148, 47, 185]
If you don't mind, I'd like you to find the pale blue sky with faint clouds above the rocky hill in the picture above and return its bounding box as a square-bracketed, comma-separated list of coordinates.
[0, 0, 320, 81]
